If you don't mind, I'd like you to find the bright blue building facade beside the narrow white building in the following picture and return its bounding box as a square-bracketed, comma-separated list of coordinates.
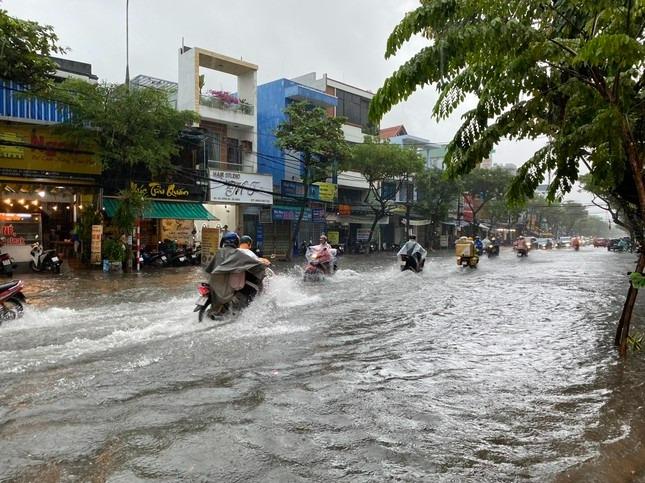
[257, 79, 337, 254]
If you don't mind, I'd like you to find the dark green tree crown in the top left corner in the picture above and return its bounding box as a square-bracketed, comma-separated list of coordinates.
[0, 10, 66, 91]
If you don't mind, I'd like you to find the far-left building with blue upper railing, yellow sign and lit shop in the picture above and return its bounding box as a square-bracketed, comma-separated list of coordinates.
[0, 58, 101, 262]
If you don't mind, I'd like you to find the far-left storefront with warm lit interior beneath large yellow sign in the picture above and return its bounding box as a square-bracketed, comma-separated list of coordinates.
[0, 122, 101, 262]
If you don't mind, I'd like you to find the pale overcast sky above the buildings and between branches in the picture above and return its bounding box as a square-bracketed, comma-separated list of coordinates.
[0, 0, 600, 214]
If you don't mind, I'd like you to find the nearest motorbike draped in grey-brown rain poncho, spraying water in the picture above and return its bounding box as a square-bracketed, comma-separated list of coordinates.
[193, 247, 273, 322]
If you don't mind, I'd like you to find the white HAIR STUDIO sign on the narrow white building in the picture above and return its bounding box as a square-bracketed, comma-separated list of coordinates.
[210, 169, 273, 205]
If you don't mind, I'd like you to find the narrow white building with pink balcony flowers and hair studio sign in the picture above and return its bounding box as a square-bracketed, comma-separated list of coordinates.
[177, 46, 273, 250]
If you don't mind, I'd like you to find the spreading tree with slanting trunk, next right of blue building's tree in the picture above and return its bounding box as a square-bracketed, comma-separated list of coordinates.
[341, 136, 424, 245]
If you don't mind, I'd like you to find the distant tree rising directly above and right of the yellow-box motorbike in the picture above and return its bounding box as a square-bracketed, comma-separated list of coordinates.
[462, 167, 511, 233]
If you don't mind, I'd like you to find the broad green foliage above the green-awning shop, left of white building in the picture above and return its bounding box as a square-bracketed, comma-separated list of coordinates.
[56, 80, 198, 177]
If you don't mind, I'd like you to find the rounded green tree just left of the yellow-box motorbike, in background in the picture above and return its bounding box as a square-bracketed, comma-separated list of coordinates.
[414, 168, 461, 246]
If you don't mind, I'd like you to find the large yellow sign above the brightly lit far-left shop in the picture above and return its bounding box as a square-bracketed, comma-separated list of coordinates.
[0, 123, 101, 176]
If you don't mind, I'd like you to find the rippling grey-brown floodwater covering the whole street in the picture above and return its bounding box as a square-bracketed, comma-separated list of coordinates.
[0, 247, 645, 482]
